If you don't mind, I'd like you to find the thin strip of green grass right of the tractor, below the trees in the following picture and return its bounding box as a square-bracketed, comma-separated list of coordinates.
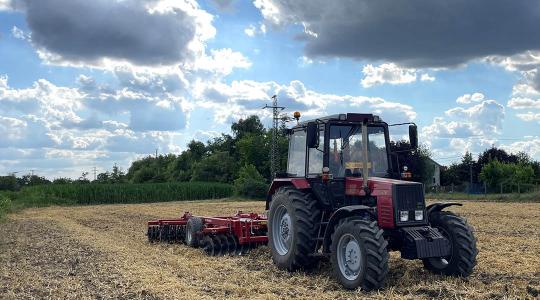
[426, 192, 540, 202]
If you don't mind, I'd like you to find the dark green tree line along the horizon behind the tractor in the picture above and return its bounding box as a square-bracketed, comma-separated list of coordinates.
[0, 116, 540, 197]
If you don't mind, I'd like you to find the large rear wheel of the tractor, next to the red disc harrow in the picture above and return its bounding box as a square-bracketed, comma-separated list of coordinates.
[268, 187, 321, 271]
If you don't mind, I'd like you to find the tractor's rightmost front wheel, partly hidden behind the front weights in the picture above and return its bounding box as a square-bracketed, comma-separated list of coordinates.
[423, 211, 478, 277]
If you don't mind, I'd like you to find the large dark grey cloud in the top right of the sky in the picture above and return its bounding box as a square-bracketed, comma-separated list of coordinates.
[254, 0, 540, 67]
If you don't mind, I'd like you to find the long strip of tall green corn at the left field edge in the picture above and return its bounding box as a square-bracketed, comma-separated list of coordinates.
[21, 182, 233, 206]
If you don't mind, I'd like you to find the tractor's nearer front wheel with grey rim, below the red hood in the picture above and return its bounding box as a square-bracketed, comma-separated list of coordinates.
[330, 218, 389, 291]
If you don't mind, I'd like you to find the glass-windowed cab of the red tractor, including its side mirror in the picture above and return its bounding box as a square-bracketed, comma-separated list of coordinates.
[280, 113, 417, 179]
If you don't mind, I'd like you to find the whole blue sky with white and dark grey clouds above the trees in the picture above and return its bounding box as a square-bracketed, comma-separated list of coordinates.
[0, 0, 540, 178]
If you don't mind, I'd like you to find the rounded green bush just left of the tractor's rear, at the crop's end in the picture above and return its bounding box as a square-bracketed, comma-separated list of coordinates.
[234, 165, 268, 199]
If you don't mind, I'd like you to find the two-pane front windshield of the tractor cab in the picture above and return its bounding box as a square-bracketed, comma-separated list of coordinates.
[328, 125, 388, 177]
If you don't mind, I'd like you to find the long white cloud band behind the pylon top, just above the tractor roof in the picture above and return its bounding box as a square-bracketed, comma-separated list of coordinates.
[196, 80, 416, 123]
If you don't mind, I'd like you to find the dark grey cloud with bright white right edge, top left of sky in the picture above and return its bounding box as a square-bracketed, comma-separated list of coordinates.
[16, 0, 215, 65]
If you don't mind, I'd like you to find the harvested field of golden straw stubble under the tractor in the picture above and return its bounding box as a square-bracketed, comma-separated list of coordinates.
[0, 201, 540, 300]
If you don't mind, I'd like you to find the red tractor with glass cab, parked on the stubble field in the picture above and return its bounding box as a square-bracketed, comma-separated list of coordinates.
[266, 113, 478, 290]
